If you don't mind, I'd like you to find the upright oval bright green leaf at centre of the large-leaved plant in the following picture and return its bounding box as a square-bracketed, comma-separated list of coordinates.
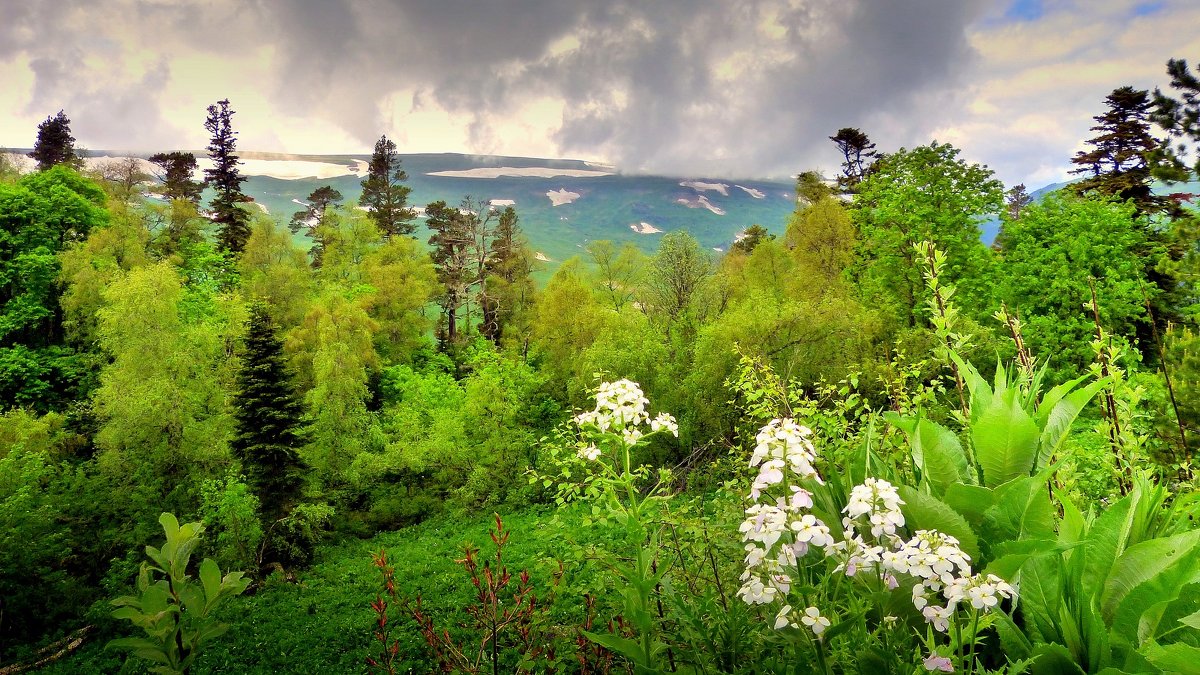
[971, 389, 1039, 488]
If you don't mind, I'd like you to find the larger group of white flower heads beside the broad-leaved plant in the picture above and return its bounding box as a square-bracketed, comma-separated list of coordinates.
[738, 419, 1016, 637]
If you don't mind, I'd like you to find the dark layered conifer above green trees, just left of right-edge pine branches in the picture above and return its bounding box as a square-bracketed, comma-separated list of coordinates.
[1070, 86, 1162, 214]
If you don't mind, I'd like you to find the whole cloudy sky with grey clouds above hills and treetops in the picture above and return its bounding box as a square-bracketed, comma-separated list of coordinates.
[0, 0, 1200, 186]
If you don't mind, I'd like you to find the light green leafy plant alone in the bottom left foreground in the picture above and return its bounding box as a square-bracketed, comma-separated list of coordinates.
[108, 513, 250, 674]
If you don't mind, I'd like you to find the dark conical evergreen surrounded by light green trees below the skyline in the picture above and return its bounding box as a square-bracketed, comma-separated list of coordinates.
[232, 304, 305, 521]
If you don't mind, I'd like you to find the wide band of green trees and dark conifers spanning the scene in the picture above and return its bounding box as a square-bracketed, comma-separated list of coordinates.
[0, 60, 1200, 659]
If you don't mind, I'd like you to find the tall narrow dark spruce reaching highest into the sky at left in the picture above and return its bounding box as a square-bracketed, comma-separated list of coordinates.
[204, 98, 250, 253]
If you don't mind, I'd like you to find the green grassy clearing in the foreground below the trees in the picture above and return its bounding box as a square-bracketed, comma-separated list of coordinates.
[43, 507, 607, 675]
